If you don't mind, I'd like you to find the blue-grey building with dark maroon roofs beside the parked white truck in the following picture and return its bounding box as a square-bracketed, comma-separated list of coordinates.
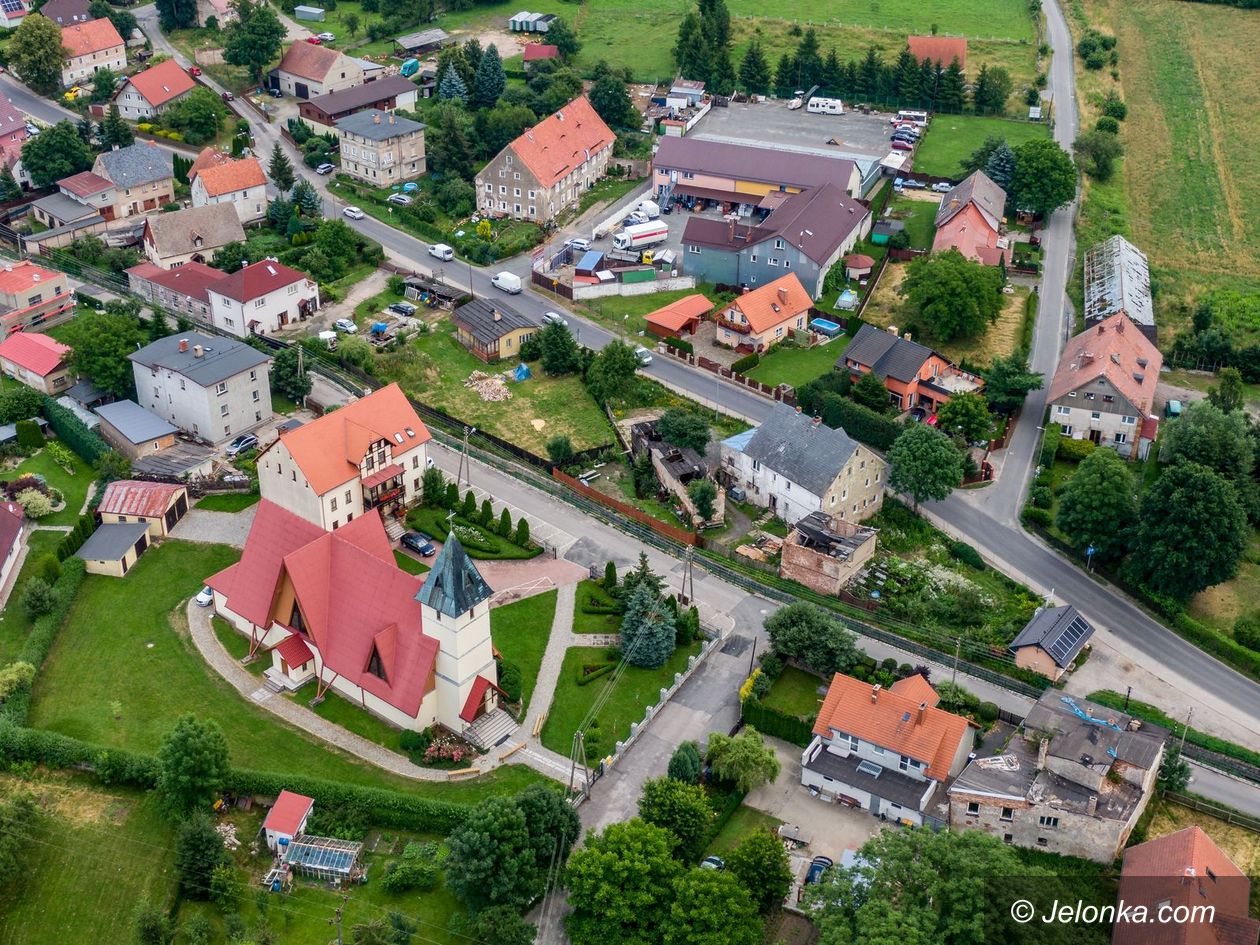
[683, 184, 871, 299]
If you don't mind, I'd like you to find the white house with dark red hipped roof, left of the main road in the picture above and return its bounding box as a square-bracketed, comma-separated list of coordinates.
[207, 259, 319, 338]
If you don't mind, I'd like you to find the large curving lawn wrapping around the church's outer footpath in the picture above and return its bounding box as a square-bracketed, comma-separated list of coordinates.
[30, 541, 539, 801]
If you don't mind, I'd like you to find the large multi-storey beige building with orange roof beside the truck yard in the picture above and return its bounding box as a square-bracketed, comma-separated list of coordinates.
[475, 95, 616, 223]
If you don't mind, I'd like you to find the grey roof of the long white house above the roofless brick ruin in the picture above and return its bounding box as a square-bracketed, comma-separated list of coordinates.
[727, 403, 858, 495]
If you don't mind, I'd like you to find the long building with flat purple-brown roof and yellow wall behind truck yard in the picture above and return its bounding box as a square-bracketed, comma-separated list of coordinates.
[651, 137, 862, 206]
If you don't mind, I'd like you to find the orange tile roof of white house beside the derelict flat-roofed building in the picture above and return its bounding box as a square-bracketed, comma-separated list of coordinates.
[814, 673, 970, 781]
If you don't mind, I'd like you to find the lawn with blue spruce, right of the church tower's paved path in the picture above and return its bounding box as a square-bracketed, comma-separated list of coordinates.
[542, 641, 701, 764]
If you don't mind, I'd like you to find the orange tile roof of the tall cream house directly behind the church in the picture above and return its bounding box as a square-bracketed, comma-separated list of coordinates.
[268, 384, 430, 495]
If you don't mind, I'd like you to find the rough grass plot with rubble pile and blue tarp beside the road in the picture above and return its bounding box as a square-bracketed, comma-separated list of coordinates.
[377, 321, 612, 456]
